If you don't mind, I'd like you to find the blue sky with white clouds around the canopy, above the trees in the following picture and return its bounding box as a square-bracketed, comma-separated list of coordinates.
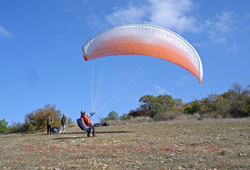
[0, 0, 250, 123]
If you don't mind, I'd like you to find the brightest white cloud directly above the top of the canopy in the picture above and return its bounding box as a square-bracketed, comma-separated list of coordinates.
[105, 0, 199, 32]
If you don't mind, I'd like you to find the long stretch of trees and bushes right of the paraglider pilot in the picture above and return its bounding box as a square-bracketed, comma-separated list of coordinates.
[106, 83, 250, 120]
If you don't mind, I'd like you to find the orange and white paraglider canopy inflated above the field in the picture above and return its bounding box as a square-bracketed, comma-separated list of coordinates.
[83, 24, 203, 83]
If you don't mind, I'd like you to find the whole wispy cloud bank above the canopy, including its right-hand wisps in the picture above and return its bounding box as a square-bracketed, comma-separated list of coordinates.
[105, 0, 235, 45]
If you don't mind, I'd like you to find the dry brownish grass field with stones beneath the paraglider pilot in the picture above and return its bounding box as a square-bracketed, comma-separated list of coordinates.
[0, 119, 250, 170]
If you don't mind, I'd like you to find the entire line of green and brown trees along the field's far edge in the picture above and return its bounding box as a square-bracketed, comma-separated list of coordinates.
[0, 83, 250, 133]
